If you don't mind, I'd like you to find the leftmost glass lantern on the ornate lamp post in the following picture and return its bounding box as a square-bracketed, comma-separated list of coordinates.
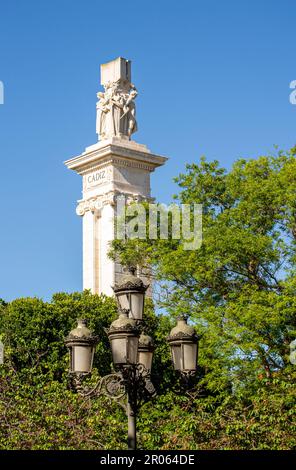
[65, 320, 98, 374]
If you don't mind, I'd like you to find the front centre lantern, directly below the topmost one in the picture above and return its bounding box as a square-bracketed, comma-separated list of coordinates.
[108, 311, 139, 368]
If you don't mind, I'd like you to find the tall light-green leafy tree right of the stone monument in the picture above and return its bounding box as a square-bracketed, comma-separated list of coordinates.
[111, 148, 296, 396]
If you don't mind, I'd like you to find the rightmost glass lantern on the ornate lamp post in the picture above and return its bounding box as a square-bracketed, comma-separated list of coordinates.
[167, 316, 199, 375]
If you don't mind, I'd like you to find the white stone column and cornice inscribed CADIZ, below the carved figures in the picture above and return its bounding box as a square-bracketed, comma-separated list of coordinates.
[65, 136, 167, 295]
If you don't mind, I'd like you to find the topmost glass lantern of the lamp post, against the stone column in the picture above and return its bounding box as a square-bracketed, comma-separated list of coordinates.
[113, 267, 149, 321]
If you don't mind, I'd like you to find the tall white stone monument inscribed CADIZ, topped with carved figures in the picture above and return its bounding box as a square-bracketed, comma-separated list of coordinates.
[65, 57, 167, 295]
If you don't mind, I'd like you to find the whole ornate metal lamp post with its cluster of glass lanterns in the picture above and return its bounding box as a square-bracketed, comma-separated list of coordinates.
[65, 270, 198, 450]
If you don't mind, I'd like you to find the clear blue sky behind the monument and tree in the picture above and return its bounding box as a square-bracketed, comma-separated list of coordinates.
[0, 0, 296, 300]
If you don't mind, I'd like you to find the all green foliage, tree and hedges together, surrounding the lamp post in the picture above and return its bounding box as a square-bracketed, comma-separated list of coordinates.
[0, 149, 296, 449]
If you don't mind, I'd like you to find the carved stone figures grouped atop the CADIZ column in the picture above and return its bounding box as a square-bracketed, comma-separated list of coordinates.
[96, 80, 138, 140]
